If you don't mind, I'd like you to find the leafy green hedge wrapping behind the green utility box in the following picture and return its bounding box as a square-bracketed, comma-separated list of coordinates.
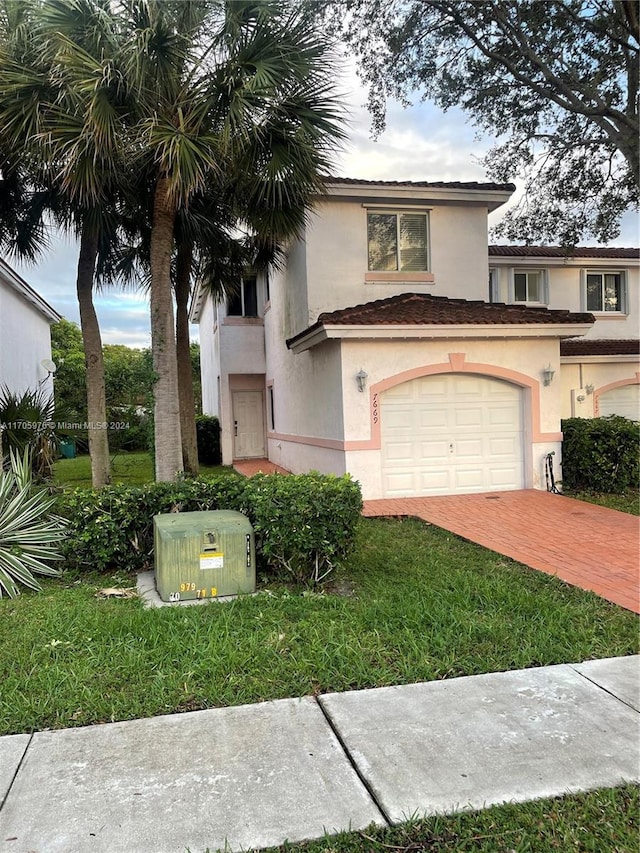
[58, 472, 362, 583]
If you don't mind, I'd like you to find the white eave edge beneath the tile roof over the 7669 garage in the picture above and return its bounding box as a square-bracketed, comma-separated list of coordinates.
[287, 322, 593, 353]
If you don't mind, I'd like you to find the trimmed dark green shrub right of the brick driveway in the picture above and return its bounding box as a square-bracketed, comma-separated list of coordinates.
[562, 415, 640, 494]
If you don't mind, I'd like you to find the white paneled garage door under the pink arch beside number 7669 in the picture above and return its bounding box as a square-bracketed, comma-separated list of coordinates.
[380, 373, 524, 497]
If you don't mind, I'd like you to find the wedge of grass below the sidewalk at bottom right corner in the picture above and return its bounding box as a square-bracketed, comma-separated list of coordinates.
[224, 785, 640, 853]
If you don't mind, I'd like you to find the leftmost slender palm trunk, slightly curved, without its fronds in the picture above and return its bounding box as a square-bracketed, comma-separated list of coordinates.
[76, 225, 111, 489]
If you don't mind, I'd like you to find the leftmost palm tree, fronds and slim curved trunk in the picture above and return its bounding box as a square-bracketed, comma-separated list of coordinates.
[0, 0, 130, 487]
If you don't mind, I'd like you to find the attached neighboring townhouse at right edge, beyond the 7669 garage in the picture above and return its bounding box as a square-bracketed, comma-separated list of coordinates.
[489, 246, 640, 419]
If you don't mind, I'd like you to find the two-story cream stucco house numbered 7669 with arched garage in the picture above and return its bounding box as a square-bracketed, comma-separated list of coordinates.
[191, 178, 638, 498]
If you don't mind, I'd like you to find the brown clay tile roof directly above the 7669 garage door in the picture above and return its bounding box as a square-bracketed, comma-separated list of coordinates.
[316, 293, 594, 326]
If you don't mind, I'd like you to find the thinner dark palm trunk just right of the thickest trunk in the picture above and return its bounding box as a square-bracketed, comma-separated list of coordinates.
[175, 243, 199, 474]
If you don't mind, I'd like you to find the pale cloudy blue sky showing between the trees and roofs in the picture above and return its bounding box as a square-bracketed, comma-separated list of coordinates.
[6, 62, 638, 347]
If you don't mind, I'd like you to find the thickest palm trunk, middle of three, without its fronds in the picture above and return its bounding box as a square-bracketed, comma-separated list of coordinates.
[150, 178, 183, 482]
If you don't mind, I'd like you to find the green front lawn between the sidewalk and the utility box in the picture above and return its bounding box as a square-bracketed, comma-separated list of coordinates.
[0, 519, 638, 734]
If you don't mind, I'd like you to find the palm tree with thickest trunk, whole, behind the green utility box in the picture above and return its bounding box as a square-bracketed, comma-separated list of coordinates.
[114, 0, 342, 480]
